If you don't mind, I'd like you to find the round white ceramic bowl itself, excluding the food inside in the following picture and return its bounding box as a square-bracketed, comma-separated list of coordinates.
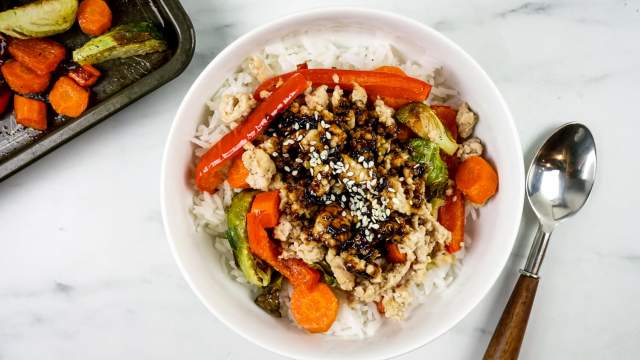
[161, 8, 524, 359]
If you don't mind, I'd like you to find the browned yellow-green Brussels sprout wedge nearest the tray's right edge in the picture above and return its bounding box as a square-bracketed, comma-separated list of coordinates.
[73, 22, 167, 64]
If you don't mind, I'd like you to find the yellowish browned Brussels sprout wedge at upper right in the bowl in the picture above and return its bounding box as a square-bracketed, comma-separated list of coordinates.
[396, 102, 458, 155]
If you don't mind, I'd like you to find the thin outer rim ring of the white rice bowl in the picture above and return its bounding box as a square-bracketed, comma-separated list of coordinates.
[160, 6, 525, 359]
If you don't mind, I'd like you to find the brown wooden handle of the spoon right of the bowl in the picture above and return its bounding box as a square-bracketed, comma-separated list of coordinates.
[484, 275, 538, 360]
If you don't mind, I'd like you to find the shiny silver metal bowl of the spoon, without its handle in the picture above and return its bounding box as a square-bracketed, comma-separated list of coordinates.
[526, 123, 596, 231]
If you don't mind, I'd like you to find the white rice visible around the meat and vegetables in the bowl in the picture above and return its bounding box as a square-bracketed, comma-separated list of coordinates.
[191, 36, 477, 339]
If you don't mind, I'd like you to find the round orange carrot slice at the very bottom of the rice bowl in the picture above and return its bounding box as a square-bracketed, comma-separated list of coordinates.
[291, 283, 339, 333]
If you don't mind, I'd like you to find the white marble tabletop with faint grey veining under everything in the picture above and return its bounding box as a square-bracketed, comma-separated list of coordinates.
[0, 0, 640, 360]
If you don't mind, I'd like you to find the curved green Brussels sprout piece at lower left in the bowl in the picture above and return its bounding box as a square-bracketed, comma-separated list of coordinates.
[227, 191, 271, 286]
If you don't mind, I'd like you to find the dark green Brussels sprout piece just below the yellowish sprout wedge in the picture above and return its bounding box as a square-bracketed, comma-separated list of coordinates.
[409, 138, 449, 199]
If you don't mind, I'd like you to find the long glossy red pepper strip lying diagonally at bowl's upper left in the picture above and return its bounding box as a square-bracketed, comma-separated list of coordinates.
[196, 74, 308, 192]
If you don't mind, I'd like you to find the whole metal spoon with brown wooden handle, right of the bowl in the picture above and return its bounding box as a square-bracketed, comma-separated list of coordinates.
[484, 123, 596, 360]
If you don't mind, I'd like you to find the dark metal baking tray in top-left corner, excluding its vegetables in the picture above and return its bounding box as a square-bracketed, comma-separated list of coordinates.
[0, 0, 195, 181]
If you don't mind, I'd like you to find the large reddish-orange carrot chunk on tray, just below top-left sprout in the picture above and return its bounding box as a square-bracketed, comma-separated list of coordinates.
[9, 39, 66, 75]
